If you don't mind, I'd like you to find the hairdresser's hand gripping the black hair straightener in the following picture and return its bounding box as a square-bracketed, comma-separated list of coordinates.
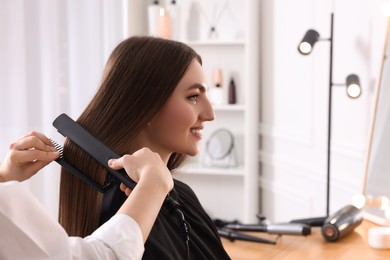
[109, 148, 173, 195]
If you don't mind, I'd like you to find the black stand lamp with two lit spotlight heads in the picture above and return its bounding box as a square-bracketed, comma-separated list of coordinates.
[298, 13, 361, 216]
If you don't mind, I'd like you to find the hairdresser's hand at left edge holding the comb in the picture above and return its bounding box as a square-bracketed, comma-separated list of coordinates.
[0, 132, 60, 182]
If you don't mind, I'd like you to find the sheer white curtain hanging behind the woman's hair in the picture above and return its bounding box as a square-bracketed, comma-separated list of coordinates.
[0, 0, 123, 216]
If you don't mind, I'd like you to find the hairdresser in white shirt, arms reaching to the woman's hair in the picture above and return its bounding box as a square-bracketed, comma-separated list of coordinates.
[0, 132, 173, 260]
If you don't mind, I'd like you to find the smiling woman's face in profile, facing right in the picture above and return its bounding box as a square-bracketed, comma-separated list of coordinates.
[144, 60, 214, 160]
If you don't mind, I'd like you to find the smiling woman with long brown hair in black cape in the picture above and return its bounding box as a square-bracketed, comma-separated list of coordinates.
[59, 37, 229, 259]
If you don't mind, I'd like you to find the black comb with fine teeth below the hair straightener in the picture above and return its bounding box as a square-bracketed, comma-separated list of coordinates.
[50, 139, 113, 193]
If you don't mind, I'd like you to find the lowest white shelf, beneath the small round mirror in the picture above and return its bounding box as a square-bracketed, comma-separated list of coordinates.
[179, 163, 245, 176]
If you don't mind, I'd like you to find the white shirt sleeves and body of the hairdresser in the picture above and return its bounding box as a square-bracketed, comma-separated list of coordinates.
[0, 181, 144, 260]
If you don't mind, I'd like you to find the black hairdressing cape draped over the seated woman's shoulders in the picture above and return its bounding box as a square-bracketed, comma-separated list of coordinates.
[101, 180, 230, 260]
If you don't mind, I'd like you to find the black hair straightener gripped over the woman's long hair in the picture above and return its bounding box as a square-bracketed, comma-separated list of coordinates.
[53, 114, 136, 189]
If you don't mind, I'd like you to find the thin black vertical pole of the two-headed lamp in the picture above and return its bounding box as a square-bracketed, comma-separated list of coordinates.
[326, 13, 333, 216]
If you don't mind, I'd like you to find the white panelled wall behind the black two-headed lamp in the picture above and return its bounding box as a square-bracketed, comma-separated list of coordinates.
[259, 0, 386, 221]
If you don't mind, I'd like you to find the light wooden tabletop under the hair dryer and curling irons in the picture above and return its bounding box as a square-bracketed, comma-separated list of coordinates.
[222, 220, 390, 260]
